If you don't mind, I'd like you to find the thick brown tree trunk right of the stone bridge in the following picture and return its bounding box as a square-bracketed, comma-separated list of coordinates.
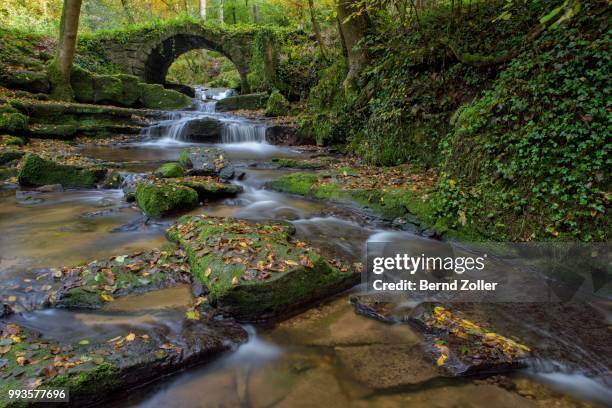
[337, 0, 370, 90]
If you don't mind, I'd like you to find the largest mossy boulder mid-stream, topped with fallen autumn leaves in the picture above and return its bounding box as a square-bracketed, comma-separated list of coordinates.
[167, 215, 359, 321]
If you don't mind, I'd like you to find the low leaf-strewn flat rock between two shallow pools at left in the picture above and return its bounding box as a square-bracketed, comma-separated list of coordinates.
[50, 248, 191, 309]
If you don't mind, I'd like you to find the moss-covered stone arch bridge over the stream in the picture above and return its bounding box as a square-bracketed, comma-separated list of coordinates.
[98, 21, 273, 92]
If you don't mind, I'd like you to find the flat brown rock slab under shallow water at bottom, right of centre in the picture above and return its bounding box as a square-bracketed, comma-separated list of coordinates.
[335, 344, 444, 390]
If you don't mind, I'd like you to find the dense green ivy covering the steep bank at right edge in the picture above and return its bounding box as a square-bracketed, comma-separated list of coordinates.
[440, 2, 612, 241]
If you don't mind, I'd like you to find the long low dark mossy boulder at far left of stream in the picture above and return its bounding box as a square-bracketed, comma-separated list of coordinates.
[17, 154, 106, 188]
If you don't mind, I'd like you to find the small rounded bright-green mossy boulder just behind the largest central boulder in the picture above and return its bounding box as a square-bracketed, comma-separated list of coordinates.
[136, 180, 199, 218]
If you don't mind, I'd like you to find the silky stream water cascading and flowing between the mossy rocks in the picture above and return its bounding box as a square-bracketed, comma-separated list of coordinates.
[0, 88, 612, 408]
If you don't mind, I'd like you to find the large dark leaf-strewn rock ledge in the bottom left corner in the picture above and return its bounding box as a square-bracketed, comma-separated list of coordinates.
[0, 319, 248, 406]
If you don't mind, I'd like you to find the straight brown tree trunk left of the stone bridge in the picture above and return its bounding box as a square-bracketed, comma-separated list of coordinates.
[49, 0, 82, 100]
